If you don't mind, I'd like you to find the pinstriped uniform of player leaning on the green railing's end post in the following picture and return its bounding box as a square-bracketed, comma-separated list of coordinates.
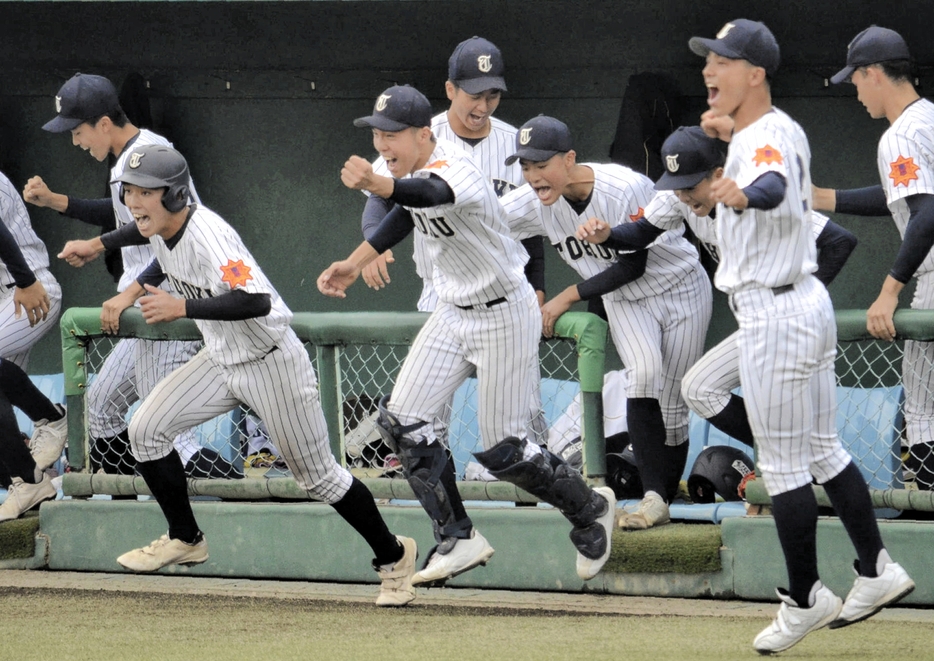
[503, 163, 712, 445]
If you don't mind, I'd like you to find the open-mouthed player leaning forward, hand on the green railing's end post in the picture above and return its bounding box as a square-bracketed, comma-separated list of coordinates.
[503, 115, 712, 529]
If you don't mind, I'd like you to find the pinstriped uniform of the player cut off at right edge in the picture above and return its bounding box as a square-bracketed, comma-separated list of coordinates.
[878, 99, 934, 445]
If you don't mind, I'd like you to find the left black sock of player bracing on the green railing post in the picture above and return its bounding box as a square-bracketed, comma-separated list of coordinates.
[626, 397, 672, 498]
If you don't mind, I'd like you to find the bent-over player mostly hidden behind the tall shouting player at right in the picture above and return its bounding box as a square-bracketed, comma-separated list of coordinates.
[577, 126, 857, 447]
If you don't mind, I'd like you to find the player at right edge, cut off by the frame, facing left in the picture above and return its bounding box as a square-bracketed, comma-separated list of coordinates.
[815, 26, 934, 489]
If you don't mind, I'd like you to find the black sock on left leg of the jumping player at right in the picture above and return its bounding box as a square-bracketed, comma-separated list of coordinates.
[772, 484, 820, 608]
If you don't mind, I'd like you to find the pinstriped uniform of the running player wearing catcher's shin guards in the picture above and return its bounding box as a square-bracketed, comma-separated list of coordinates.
[389, 139, 542, 448]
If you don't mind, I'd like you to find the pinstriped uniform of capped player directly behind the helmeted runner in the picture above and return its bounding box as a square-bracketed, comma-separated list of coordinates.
[87, 129, 200, 448]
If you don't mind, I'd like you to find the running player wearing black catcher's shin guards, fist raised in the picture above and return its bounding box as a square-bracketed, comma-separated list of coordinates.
[318, 86, 615, 585]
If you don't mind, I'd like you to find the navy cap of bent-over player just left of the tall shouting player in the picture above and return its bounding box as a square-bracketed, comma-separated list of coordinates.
[655, 126, 726, 190]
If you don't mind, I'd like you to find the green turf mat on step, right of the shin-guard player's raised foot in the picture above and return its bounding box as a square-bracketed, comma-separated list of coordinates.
[604, 523, 721, 574]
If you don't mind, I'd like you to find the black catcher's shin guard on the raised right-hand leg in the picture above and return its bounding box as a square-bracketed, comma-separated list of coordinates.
[474, 438, 609, 560]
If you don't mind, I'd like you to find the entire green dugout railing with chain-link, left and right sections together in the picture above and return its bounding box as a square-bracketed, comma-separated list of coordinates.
[61, 308, 934, 512]
